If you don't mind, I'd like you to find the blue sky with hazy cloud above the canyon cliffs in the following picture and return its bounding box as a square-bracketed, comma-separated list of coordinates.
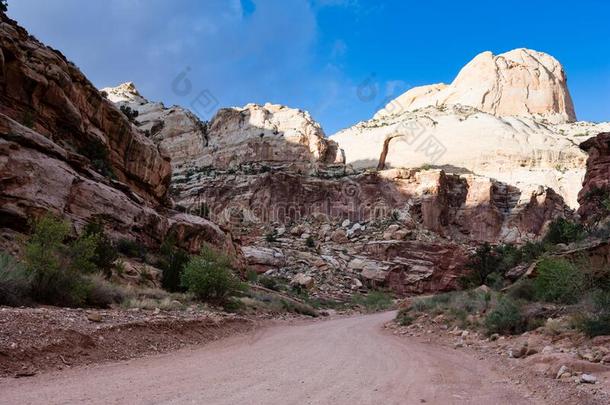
[9, 0, 610, 135]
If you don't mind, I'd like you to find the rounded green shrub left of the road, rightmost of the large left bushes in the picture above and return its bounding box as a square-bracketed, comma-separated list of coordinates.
[181, 247, 242, 304]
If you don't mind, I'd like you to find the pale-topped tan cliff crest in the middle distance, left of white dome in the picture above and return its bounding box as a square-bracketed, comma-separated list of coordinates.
[102, 83, 344, 180]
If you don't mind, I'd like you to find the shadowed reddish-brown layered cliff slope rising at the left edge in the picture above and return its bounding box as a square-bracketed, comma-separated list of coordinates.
[0, 13, 234, 251]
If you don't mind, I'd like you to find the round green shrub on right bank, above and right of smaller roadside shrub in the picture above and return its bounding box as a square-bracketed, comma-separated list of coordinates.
[533, 258, 585, 304]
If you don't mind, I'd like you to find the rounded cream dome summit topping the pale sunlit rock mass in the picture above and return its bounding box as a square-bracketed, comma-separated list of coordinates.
[375, 48, 576, 123]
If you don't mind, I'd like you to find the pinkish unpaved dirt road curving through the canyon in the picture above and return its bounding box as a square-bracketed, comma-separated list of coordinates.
[0, 313, 532, 405]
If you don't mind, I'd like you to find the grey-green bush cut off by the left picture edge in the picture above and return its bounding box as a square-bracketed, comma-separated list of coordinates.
[0, 252, 31, 307]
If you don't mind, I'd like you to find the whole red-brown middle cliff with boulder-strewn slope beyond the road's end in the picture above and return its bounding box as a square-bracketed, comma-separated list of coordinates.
[104, 84, 584, 298]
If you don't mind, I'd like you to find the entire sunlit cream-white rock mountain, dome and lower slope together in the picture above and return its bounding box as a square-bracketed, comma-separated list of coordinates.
[331, 49, 610, 208]
